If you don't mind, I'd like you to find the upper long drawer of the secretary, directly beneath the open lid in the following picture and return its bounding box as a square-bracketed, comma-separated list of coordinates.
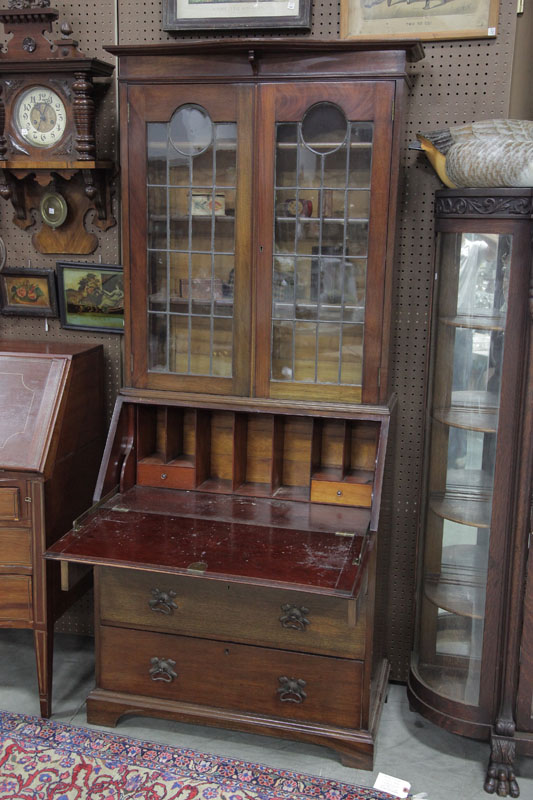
[98, 567, 366, 658]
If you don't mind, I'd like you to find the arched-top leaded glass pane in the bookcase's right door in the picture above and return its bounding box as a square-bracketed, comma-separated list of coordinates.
[271, 102, 373, 387]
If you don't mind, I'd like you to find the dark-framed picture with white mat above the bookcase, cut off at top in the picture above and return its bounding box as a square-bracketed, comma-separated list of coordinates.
[163, 0, 311, 31]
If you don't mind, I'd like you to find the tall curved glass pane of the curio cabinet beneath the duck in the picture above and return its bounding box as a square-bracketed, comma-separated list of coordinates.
[418, 233, 512, 705]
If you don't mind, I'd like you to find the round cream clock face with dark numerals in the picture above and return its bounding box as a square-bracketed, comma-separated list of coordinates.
[13, 86, 67, 147]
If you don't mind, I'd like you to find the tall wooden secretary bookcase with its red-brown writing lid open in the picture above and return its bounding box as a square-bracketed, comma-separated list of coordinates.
[48, 39, 422, 768]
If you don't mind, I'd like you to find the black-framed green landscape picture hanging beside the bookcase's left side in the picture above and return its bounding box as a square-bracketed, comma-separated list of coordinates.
[57, 261, 124, 333]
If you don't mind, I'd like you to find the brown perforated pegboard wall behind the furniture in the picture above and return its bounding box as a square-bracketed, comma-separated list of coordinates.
[0, 0, 530, 680]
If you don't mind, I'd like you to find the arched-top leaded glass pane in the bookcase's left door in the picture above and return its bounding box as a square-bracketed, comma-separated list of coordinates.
[146, 103, 237, 378]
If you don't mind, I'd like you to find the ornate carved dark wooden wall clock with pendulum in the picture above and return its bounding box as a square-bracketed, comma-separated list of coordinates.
[0, 0, 115, 254]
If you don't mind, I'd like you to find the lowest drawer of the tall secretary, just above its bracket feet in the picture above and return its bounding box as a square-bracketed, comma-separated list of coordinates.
[99, 626, 363, 728]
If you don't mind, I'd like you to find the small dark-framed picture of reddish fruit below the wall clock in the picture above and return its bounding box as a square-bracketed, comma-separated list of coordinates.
[0, 267, 57, 317]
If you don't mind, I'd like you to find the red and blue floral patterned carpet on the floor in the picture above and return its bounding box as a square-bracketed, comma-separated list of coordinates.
[0, 711, 391, 800]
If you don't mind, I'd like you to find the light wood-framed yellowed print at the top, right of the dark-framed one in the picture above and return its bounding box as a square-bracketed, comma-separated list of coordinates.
[341, 0, 498, 41]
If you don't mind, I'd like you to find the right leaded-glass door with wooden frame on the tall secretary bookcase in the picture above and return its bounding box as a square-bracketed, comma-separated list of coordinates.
[256, 83, 393, 403]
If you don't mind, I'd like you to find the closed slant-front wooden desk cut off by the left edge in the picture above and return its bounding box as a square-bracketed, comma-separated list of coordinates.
[0, 340, 105, 717]
